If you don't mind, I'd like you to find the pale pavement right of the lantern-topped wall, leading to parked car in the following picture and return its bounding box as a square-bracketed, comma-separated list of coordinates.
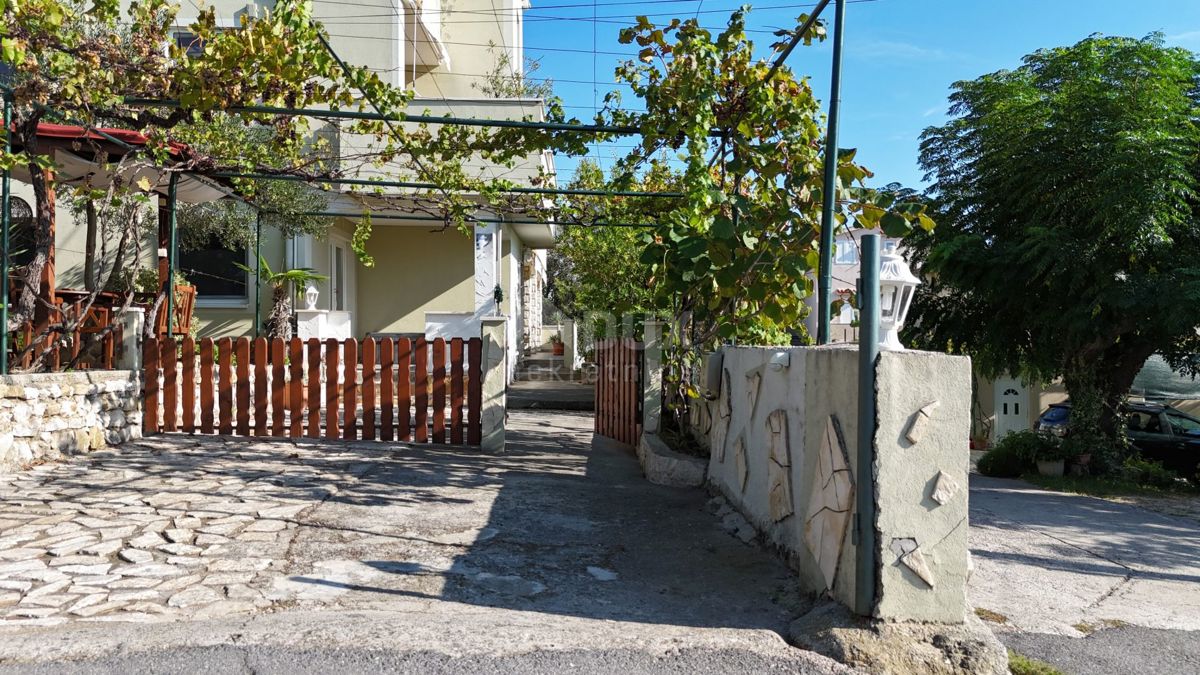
[970, 474, 1200, 673]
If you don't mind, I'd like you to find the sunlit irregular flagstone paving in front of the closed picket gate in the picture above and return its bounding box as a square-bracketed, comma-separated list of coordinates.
[0, 436, 370, 627]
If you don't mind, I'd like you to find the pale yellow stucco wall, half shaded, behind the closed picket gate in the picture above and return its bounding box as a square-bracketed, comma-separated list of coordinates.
[356, 226, 475, 335]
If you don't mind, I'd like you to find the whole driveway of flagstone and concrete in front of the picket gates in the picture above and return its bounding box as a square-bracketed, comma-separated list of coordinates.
[0, 412, 840, 673]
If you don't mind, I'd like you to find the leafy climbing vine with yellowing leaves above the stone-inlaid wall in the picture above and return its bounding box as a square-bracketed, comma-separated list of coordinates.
[597, 10, 932, 400]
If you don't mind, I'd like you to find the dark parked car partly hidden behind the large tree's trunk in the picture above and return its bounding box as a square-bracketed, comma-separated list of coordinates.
[1037, 402, 1200, 478]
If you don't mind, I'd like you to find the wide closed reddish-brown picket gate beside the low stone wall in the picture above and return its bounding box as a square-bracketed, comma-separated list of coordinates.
[143, 338, 484, 446]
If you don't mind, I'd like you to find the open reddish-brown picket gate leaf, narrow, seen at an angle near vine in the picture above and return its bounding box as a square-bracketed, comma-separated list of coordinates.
[595, 338, 643, 446]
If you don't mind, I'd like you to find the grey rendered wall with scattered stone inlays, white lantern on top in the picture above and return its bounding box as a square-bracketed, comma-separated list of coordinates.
[698, 346, 971, 623]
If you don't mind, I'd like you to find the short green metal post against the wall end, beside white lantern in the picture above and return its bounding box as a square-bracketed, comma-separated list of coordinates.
[854, 233, 880, 616]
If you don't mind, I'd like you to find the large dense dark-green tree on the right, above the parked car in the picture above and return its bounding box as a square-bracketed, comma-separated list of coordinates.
[905, 35, 1200, 466]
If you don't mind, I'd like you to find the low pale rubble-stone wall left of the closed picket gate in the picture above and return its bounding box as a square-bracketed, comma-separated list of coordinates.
[0, 370, 142, 472]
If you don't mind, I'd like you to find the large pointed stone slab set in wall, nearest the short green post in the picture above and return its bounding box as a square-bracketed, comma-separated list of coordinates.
[804, 414, 854, 589]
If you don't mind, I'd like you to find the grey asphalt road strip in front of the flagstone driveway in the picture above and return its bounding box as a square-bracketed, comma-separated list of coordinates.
[0, 645, 850, 675]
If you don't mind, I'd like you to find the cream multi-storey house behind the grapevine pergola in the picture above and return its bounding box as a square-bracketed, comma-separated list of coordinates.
[4, 0, 556, 381]
